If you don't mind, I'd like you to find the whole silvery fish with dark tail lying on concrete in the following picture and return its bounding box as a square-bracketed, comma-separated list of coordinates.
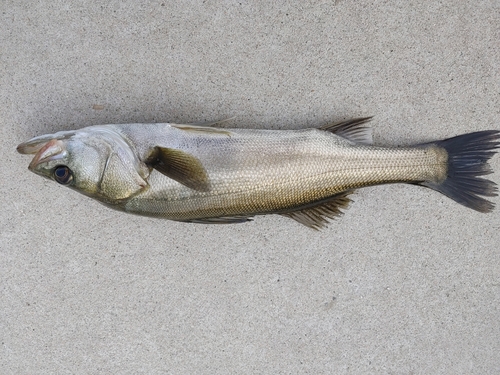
[17, 117, 500, 229]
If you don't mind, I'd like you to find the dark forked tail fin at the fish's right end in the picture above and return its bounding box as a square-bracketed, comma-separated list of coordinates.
[421, 130, 500, 212]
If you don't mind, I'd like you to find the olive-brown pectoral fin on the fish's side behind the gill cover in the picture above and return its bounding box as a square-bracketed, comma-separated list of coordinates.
[146, 146, 210, 191]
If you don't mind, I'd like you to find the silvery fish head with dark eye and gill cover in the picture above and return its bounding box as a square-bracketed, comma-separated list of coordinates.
[17, 126, 149, 205]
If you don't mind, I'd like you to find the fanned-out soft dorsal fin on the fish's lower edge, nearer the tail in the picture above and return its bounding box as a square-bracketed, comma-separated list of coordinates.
[281, 190, 353, 230]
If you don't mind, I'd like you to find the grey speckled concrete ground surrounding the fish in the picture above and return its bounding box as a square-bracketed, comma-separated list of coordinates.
[0, 0, 500, 374]
